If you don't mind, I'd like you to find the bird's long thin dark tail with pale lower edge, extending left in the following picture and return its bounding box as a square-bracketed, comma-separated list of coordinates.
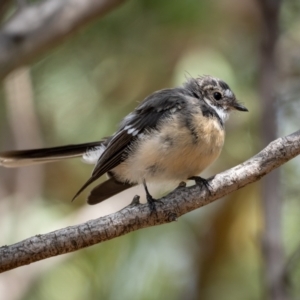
[0, 141, 103, 168]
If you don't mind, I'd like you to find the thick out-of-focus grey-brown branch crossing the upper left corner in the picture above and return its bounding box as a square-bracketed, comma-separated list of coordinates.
[0, 0, 125, 79]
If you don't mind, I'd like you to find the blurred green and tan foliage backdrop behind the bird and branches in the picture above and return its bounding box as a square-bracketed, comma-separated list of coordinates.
[0, 0, 300, 300]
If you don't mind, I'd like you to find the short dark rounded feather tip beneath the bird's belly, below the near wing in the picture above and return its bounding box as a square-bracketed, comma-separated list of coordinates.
[87, 178, 135, 205]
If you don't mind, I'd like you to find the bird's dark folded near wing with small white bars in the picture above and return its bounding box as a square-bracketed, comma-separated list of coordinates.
[73, 88, 191, 199]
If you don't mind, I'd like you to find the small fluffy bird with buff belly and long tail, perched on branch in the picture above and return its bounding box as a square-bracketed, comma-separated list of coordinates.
[0, 75, 248, 210]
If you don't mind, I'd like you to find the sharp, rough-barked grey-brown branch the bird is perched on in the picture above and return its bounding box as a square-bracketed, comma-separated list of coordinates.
[0, 130, 300, 272]
